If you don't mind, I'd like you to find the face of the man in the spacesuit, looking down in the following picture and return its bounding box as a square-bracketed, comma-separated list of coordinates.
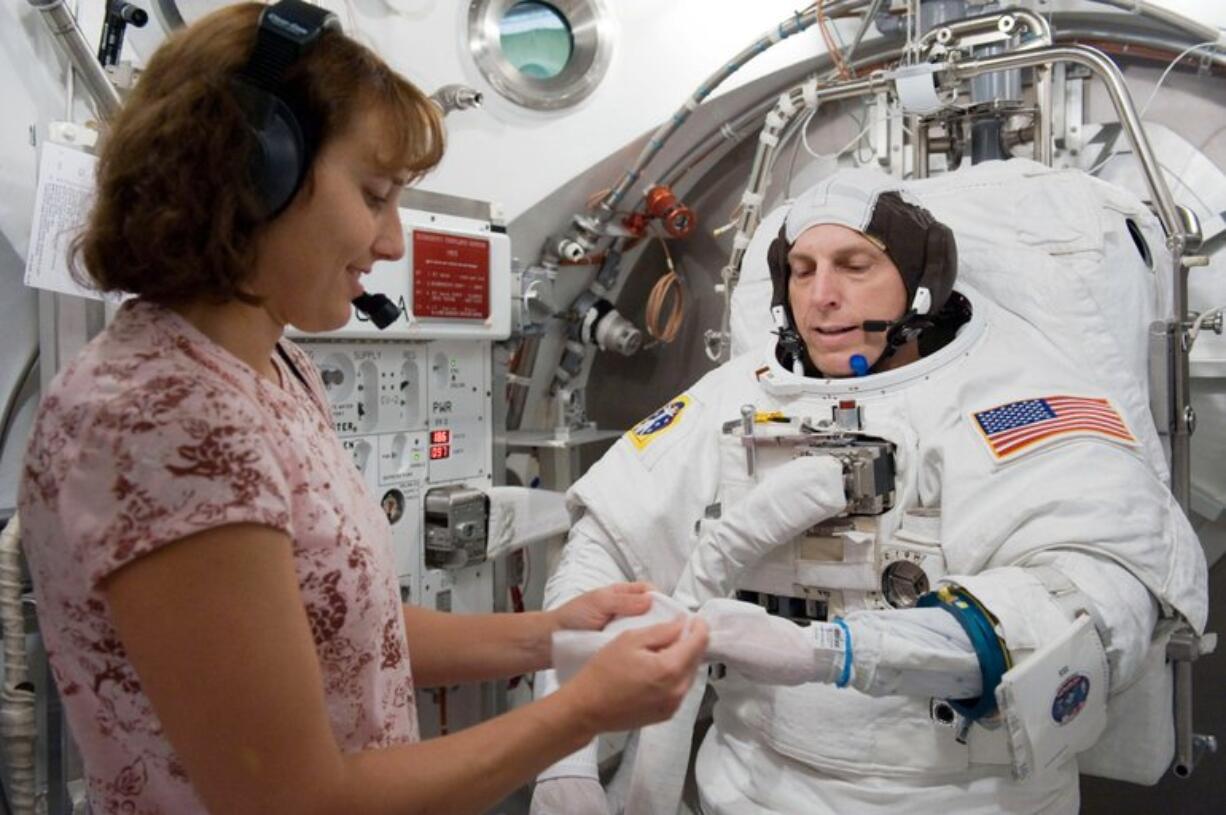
[787, 223, 910, 376]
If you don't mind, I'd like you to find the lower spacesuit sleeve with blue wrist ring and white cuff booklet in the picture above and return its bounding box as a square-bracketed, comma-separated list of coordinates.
[921, 549, 1156, 781]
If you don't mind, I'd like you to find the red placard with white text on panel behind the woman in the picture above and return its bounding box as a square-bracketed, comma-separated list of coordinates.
[413, 229, 489, 320]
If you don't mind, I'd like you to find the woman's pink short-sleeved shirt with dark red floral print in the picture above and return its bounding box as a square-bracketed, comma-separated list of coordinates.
[20, 300, 418, 815]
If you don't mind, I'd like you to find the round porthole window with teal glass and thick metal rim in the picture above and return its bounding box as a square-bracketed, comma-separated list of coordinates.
[468, 0, 612, 110]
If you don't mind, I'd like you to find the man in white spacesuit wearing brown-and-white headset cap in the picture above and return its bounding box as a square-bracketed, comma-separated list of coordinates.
[533, 170, 1206, 815]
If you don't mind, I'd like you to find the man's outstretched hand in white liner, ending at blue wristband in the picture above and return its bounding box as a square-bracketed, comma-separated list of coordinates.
[699, 598, 847, 685]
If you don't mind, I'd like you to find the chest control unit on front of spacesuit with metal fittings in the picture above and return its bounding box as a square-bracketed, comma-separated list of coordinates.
[709, 390, 944, 620]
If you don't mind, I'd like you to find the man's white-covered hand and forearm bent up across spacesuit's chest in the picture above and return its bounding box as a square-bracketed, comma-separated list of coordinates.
[673, 456, 847, 608]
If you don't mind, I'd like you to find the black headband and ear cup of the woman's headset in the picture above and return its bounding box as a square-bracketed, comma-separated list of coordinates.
[234, 0, 341, 219]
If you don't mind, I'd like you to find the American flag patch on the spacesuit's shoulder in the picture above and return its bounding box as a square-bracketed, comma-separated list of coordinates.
[972, 396, 1137, 461]
